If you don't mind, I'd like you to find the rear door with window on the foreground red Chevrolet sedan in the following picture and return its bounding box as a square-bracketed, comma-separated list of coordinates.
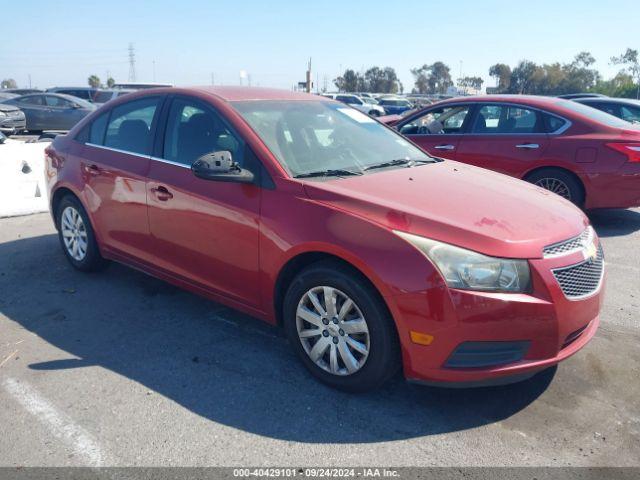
[81, 96, 163, 260]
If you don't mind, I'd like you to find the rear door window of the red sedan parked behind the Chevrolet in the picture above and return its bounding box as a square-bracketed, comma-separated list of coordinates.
[472, 105, 544, 134]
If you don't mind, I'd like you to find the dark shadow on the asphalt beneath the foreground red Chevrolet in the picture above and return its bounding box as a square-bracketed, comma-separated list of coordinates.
[0, 235, 555, 443]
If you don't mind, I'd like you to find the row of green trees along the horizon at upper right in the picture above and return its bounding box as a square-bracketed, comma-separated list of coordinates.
[334, 48, 640, 98]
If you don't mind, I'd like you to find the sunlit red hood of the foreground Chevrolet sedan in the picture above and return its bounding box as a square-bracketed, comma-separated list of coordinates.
[305, 160, 589, 258]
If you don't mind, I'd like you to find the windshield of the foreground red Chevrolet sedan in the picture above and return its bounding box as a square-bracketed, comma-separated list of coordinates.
[233, 101, 431, 177]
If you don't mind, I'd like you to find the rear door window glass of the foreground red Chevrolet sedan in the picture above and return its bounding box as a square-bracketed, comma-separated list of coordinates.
[104, 97, 160, 155]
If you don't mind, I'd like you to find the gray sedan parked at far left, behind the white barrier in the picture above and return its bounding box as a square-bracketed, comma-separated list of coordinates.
[0, 93, 97, 131]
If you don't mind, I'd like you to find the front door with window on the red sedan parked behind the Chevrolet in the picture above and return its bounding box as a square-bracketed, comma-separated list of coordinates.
[398, 104, 473, 160]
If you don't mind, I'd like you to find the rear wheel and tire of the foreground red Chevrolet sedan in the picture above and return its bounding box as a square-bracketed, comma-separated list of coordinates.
[56, 195, 106, 272]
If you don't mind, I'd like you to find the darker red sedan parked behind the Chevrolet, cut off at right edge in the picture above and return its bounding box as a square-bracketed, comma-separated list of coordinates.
[381, 95, 640, 209]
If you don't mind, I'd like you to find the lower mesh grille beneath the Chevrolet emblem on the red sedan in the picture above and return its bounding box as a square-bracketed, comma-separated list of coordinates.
[552, 246, 604, 299]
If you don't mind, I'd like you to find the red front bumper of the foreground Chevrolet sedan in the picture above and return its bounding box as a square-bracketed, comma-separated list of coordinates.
[390, 244, 604, 386]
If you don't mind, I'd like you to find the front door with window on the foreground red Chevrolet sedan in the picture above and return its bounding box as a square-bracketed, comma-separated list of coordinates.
[147, 96, 261, 306]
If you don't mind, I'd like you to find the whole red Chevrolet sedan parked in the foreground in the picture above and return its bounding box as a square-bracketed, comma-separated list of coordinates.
[46, 87, 604, 391]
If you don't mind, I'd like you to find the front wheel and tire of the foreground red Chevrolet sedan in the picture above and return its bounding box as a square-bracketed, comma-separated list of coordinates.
[283, 261, 400, 392]
